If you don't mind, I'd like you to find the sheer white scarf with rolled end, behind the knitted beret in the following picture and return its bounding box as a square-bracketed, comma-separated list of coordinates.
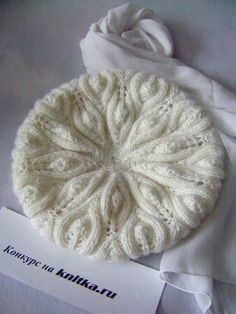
[81, 4, 236, 312]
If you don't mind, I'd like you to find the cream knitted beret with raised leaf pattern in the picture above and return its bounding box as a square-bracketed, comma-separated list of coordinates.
[12, 70, 224, 260]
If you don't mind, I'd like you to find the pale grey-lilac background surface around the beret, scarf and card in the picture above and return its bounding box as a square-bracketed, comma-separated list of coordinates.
[0, 0, 236, 314]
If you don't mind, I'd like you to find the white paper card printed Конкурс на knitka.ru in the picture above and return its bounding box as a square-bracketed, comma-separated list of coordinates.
[0, 208, 164, 314]
